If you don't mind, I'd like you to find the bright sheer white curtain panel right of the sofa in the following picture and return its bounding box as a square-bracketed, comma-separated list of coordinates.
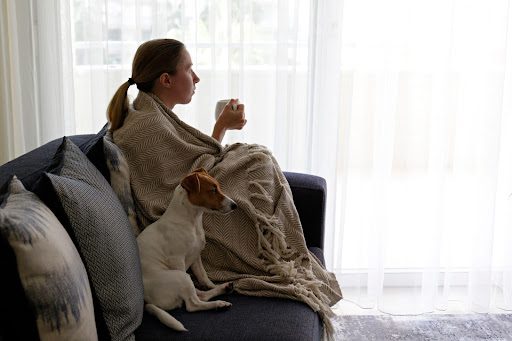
[335, 0, 512, 314]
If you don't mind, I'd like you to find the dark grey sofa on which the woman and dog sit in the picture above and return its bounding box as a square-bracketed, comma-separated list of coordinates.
[0, 130, 326, 341]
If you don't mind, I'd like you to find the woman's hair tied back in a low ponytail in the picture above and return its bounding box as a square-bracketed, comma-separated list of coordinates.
[107, 39, 185, 132]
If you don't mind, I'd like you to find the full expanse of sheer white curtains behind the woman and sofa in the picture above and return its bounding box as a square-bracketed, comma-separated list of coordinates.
[4, 0, 512, 314]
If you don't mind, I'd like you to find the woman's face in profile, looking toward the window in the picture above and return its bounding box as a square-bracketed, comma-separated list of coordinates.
[171, 48, 199, 104]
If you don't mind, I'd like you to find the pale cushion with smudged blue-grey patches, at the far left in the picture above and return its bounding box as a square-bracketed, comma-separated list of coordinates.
[0, 177, 97, 340]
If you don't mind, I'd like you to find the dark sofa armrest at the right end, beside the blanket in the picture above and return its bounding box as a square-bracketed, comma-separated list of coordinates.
[284, 172, 327, 249]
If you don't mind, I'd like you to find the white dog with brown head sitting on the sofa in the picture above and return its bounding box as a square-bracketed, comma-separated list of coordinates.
[137, 168, 237, 331]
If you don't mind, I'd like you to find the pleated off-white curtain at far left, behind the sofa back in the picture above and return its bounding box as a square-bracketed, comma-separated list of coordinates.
[0, 0, 75, 163]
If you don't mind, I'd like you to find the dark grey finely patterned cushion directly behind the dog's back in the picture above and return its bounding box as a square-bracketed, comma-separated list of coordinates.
[34, 138, 143, 340]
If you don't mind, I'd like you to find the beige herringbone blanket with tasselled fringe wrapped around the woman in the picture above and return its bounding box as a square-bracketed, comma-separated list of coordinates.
[114, 92, 341, 334]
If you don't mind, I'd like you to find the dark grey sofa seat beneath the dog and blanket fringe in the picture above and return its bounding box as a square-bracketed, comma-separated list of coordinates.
[135, 294, 323, 341]
